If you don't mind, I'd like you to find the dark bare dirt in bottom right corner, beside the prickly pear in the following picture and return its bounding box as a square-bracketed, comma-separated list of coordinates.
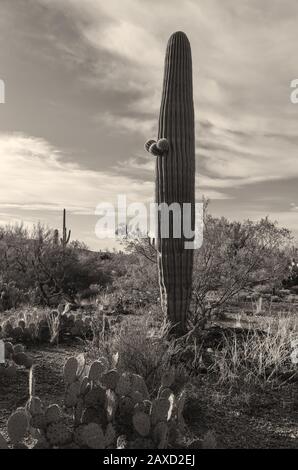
[185, 378, 298, 449]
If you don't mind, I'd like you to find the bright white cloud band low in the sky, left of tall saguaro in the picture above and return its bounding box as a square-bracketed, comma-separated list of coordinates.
[0, 134, 153, 214]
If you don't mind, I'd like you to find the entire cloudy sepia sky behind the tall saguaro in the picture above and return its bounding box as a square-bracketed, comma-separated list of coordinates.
[0, 0, 298, 249]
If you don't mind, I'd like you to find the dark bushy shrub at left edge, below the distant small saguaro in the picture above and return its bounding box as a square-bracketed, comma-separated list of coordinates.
[0, 225, 111, 310]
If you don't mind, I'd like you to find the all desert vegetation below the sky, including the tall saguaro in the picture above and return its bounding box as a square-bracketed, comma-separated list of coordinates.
[0, 32, 298, 449]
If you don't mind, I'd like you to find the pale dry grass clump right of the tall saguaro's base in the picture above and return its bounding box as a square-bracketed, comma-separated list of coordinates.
[210, 316, 298, 386]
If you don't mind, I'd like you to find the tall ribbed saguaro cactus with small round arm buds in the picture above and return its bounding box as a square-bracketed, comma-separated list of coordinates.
[145, 32, 195, 334]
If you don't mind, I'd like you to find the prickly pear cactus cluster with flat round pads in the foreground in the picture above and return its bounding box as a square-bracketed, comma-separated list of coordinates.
[4, 355, 183, 449]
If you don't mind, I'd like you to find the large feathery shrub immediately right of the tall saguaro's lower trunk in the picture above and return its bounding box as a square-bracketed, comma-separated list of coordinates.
[192, 210, 291, 327]
